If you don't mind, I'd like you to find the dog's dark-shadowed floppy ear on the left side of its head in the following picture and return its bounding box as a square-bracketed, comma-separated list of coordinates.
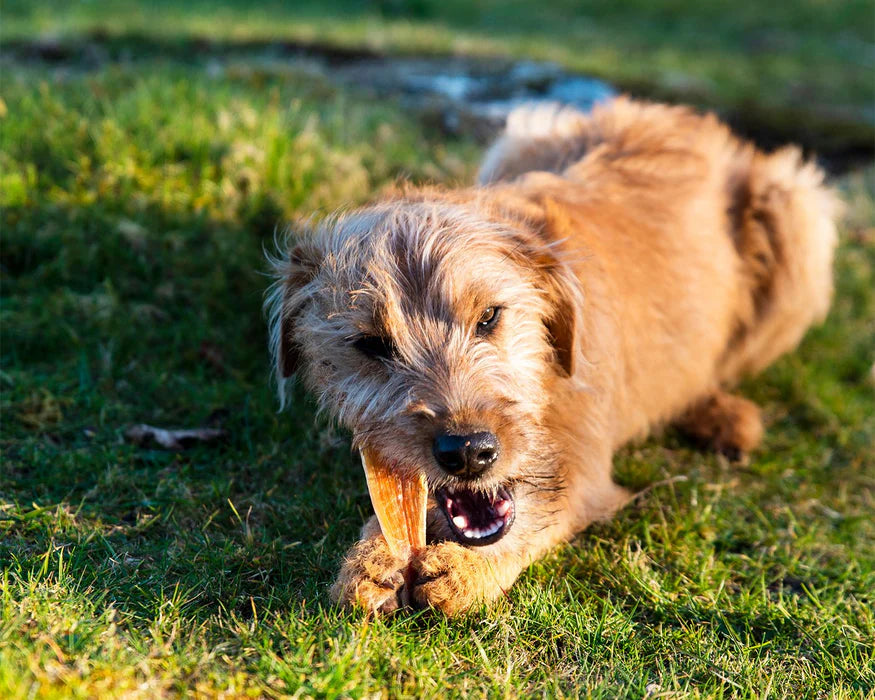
[276, 244, 319, 379]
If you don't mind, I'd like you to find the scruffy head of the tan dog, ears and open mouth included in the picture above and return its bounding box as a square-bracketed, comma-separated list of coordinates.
[272, 202, 577, 546]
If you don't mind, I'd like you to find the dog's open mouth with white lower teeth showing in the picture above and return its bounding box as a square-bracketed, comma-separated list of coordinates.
[435, 486, 516, 546]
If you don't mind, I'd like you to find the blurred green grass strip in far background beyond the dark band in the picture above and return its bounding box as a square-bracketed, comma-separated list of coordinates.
[0, 0, 875, 160]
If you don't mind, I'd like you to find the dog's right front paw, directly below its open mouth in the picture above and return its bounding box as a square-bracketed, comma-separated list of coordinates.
[410, 542, 503, 615]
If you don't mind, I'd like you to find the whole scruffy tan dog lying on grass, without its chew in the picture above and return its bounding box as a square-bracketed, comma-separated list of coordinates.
[268, 99, 838, 613]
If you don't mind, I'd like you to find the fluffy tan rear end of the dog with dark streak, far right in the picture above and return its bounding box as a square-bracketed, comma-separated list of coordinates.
[721, 146, 843, 383]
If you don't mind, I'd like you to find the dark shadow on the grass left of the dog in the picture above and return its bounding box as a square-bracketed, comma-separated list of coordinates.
[0, 193, 368, 616]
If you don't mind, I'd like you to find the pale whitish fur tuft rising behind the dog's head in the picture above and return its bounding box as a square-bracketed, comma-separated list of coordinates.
[477, 103, 590, 185]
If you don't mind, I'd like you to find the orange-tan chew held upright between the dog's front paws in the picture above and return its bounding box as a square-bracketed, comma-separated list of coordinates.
[361, 449, 428, 560]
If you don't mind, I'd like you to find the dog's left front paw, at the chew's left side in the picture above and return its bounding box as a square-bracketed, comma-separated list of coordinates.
[331, 535, 406, 613]
